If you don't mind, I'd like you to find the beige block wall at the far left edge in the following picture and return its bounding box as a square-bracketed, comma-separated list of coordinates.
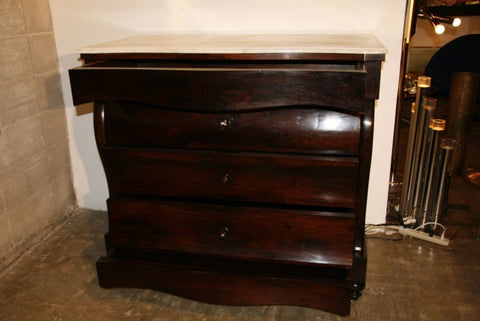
[0, 0, 76, 272]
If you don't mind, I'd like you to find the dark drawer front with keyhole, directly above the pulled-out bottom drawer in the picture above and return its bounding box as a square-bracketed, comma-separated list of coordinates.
[108, 199, 355, 267]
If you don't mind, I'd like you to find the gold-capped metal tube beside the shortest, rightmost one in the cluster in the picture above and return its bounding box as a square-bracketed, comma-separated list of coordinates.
[422, 119, 445, 224]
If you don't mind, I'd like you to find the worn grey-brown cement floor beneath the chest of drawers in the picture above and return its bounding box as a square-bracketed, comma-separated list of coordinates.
[0, 190, 480, 321]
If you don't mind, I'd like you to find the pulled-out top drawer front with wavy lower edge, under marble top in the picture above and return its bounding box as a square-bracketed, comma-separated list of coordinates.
[70, 65, 367, 113]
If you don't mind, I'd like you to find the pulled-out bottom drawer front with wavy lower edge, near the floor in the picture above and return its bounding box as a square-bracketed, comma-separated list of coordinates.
[97, 257, 352, 315]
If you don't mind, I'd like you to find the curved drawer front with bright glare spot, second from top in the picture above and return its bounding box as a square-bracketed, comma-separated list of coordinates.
[105, 102, 360, 155]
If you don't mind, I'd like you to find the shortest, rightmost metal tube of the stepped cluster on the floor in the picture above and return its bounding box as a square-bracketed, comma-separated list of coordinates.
[433, 138, 455, 229]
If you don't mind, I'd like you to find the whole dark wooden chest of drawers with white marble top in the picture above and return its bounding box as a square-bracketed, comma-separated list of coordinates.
[70, 36, 384, 315]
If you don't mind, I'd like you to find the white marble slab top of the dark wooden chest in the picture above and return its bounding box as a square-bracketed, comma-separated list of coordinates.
[78, 34, 387, 54]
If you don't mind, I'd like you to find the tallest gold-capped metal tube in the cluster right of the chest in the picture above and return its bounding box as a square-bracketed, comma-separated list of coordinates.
[400, 76, 431, 217]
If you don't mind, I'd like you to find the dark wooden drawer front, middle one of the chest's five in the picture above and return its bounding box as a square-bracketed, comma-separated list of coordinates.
[103, 149, 358, 208]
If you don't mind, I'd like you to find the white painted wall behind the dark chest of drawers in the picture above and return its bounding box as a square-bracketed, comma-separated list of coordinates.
[50, 0, 405, 223]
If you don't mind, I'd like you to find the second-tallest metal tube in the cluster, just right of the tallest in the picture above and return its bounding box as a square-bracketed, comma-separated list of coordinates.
[410, 97, 437, 222]
